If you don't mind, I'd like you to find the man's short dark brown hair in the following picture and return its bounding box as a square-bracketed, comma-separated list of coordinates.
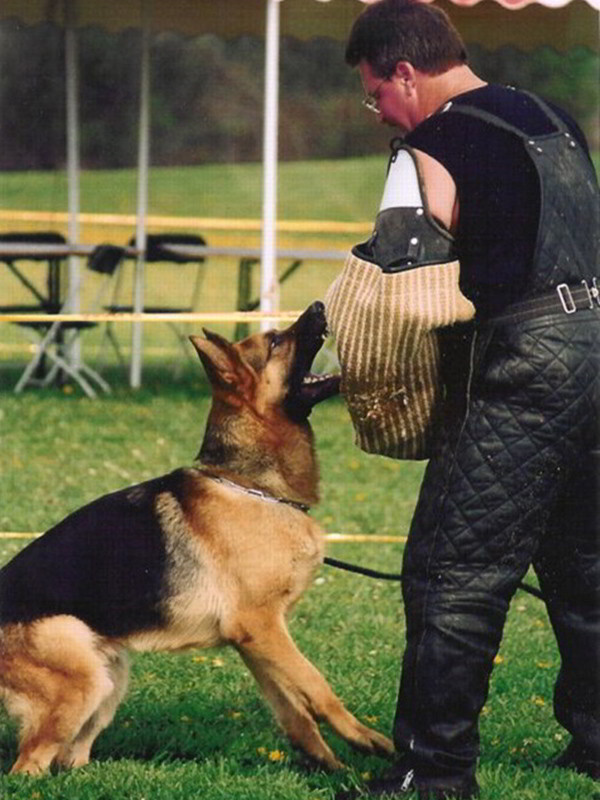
[346, 0, 467, 78]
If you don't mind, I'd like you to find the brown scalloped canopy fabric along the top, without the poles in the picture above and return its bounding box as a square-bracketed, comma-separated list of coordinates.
[0, 0, 600, 49]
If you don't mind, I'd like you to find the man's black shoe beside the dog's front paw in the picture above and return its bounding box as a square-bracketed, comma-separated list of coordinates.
[335, 759, 479, 800]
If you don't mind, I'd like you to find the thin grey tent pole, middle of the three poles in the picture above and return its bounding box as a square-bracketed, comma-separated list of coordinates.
[129, 0, 151, 389]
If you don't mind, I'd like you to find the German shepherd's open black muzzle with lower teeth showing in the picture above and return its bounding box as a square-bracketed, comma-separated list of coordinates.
[286, 301, 340, 417]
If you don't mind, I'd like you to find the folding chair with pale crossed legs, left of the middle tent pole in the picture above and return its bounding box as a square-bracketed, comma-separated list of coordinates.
[15, 245, 123, 397]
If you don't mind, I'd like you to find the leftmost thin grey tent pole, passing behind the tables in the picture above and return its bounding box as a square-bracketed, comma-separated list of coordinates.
[64, 0, 81, 367]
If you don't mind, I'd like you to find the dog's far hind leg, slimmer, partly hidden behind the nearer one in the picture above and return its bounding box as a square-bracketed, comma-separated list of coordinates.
[56, 650, 129, 769]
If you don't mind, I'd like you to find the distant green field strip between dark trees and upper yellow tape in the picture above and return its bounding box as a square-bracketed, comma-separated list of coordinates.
[0, 152, 387, 221]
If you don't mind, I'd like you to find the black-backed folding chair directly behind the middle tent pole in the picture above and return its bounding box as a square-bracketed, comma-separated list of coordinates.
[105, 233, 206, 364]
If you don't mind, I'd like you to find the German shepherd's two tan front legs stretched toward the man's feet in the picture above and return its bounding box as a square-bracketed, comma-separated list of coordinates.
[236, 620, 394, 769]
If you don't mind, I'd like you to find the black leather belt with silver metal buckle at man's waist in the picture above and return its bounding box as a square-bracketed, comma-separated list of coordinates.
[489, 278, 600, 323]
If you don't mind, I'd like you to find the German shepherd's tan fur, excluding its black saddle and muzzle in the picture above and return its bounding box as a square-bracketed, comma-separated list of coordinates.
[0, 312, 393, 774]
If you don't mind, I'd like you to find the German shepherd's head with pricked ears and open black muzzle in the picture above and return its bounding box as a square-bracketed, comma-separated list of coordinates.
[190, 302, 340, 422]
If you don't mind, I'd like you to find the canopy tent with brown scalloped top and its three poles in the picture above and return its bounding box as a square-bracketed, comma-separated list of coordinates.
[0, 0, 600, 387]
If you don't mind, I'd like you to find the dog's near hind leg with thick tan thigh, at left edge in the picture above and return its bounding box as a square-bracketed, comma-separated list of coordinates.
[0, 616, 114, 774]
